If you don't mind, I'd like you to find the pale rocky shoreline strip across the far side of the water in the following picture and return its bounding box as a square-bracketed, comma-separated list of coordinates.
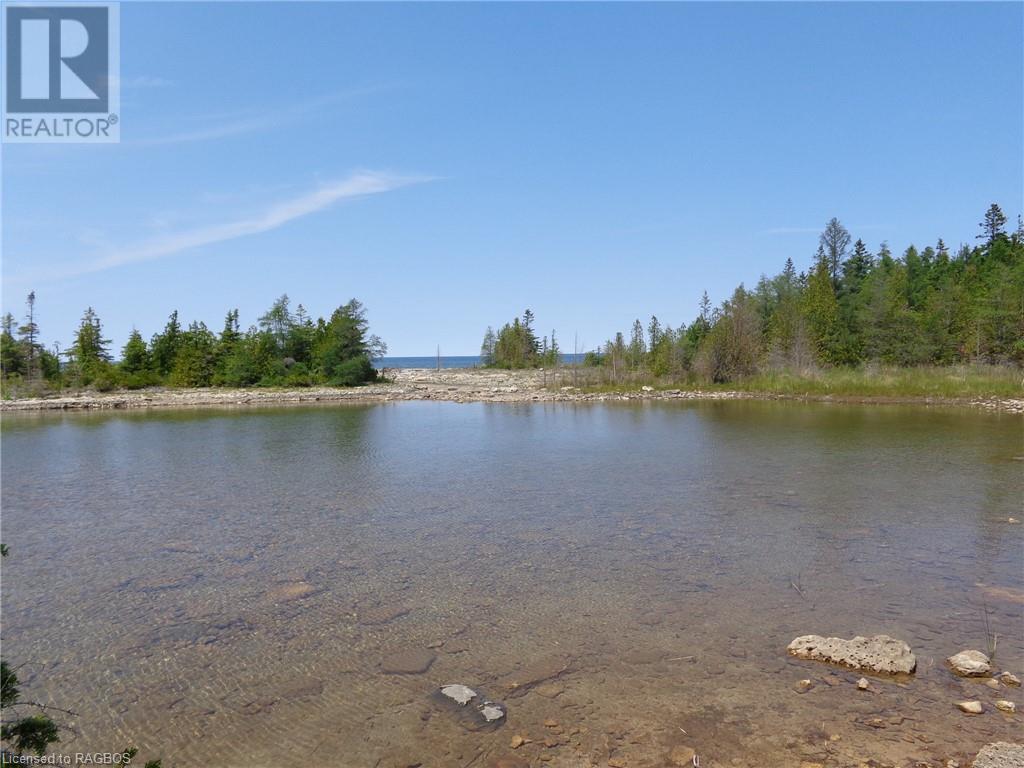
[0, 369, 1024, 414]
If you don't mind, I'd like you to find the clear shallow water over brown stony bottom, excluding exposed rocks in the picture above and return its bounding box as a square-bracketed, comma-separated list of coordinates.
[0, 402, 1024, 768]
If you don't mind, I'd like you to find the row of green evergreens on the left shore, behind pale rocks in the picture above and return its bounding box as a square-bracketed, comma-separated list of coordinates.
[0, 293, 387, 391]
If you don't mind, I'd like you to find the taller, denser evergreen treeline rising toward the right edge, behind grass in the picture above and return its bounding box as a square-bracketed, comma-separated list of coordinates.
[481, 204, 1024, 382]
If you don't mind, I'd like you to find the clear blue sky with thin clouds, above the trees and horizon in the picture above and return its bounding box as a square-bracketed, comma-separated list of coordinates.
[0, 2, 1024, 355]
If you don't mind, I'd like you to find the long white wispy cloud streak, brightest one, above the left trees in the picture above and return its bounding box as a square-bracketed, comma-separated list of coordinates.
[14, 171, 432, 283]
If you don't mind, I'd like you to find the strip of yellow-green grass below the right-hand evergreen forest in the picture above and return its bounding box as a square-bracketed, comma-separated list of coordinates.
[562, 366, 1024, 398]
